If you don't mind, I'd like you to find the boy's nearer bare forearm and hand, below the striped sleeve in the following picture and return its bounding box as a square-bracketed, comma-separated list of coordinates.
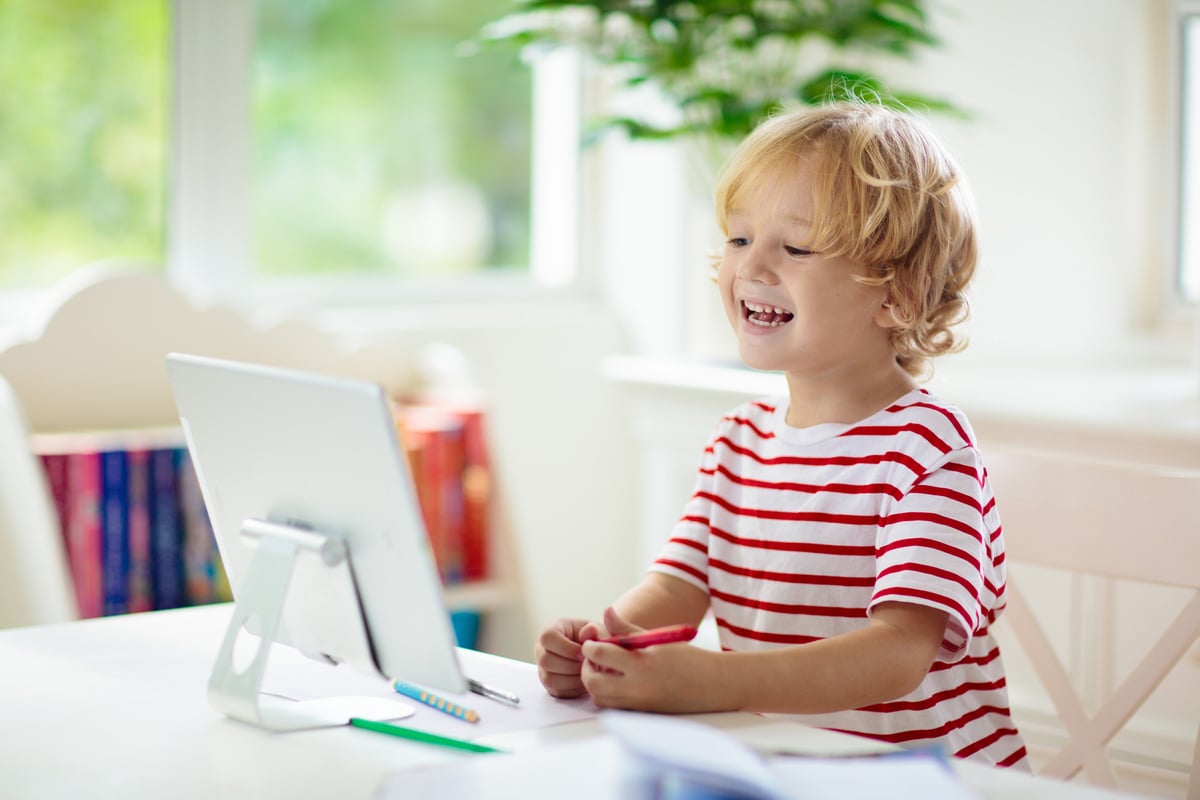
[582, 602, 946, 714]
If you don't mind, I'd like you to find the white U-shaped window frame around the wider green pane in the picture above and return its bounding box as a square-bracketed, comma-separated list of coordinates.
[164, 0, 580, 309]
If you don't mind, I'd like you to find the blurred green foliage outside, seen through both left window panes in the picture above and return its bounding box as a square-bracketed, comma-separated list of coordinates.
[0, 0, 532, 288]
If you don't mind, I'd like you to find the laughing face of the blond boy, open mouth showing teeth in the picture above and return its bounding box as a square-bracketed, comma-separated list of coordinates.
[716, 160, 895, 381]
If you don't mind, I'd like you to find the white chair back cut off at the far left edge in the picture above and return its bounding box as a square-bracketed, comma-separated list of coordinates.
[0, 377, 77, 627]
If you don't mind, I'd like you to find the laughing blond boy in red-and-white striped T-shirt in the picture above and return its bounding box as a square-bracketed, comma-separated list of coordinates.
[536, 103, 1027, 768]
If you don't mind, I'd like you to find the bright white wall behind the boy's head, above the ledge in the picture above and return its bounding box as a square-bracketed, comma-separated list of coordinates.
[593, 0, 1192, 376]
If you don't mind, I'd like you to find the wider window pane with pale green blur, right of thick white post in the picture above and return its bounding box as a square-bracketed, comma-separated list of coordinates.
[251, 0, 532, 276]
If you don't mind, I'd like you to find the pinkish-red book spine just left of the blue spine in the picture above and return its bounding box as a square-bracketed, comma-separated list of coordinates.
[66, 451, 104, 618]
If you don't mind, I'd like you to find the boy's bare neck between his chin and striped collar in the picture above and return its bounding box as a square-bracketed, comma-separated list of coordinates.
[787, 366, 917, 428]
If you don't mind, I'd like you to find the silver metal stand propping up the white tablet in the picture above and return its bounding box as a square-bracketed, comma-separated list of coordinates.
[209, 519, 408, 730]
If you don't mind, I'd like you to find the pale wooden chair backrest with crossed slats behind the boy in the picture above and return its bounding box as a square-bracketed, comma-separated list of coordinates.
[985, 447, 1200, 800]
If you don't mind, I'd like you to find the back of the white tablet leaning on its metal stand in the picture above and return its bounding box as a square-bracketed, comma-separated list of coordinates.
[167, 353, 466, 692]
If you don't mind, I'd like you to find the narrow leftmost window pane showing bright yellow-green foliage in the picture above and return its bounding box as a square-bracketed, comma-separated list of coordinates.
[0, 0, 168, 288]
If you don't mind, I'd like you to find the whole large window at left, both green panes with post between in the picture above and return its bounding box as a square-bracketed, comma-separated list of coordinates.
[0, 0, 577, 300]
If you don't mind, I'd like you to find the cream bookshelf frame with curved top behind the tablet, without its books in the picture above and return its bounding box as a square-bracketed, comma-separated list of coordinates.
[0, 264, 530, 655]
